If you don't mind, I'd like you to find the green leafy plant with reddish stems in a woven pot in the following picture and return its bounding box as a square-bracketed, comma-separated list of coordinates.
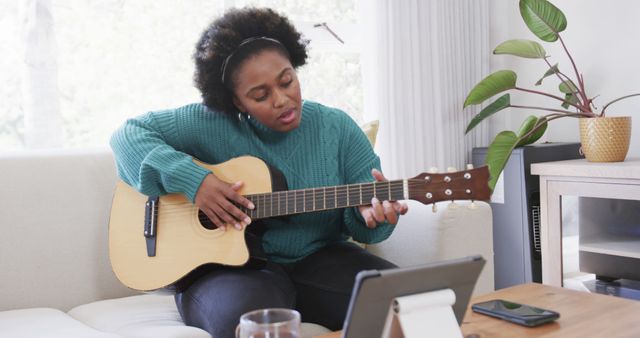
[464, 0, 640, 189]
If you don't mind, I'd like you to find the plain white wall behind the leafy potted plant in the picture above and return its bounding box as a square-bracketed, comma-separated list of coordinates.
[489, 0, 640, 157]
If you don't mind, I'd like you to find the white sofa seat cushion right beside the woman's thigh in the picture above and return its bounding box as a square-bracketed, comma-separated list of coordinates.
[69, 293, 211, 338]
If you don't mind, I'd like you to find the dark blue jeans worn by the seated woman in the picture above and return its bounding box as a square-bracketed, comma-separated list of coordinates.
[175, 243, 395, 338]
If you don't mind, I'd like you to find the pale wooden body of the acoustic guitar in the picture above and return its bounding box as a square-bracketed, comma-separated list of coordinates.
[109, 156, 273, 291]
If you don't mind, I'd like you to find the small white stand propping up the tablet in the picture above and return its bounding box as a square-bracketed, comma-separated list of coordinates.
[382, 289, 462, 338]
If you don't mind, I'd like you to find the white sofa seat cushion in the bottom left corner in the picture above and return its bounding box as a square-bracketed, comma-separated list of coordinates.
[0, 308, 121, 338]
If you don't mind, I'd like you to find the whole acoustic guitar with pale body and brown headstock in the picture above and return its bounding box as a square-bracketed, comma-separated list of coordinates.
[109, 156, 491, 291]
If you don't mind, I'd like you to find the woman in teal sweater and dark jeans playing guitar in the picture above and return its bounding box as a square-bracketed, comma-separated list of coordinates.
[111, 8, 407, 337]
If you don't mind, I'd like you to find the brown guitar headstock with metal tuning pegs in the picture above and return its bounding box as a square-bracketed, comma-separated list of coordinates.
[408, 165, 491, 204]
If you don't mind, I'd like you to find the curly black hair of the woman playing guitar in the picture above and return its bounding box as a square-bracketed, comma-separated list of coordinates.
[193, 7, 308, 114]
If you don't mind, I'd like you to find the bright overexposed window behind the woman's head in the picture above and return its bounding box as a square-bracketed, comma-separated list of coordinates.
[0, 0, 362, 149]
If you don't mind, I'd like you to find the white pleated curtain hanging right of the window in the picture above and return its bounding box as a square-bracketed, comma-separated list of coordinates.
[359, 0, 491, 178]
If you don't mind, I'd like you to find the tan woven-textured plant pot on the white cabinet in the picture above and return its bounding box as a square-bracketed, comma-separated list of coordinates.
[580, 116, 631, 162]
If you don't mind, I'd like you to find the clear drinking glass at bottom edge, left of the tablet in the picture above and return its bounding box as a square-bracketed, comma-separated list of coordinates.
[236, 309, 300, 338]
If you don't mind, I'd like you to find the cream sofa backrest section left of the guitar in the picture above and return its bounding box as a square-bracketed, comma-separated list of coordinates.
[0, 149, 134, 311]
